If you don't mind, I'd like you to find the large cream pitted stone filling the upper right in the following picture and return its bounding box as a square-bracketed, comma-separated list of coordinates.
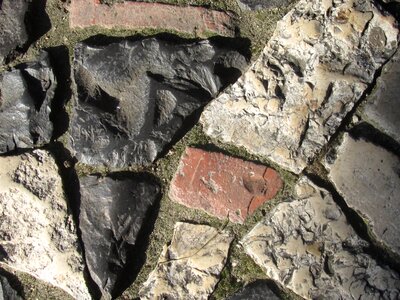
[201, 0, 399, 173]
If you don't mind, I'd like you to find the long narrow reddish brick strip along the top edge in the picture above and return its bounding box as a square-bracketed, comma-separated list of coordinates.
[69, 0, 235, 37]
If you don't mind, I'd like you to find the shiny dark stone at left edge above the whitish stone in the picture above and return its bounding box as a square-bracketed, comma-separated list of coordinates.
[0, 52, 57, 153]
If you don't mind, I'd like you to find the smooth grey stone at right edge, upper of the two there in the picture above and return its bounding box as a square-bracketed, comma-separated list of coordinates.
[361, 51, 400, 143]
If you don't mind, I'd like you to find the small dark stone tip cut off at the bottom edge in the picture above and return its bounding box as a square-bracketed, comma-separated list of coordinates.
[229, 280, 280, 300]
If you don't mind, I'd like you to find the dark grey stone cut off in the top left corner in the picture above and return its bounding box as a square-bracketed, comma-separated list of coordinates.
[0, 0, 28, 63]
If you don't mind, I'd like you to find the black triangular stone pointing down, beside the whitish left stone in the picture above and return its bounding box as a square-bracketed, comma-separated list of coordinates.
[79, 174, 160, 298]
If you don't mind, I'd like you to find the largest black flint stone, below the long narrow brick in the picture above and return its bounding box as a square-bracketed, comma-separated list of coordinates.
[69, 38, 246, 167]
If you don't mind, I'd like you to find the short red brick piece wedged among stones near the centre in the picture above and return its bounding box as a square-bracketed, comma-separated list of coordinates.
[169, 148, 282, 223]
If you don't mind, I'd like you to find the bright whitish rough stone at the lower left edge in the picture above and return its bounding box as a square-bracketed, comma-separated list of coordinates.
[0, 150, 91, 299]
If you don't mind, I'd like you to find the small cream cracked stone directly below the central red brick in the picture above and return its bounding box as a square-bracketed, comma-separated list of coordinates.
[139, 222, 233, 300]
